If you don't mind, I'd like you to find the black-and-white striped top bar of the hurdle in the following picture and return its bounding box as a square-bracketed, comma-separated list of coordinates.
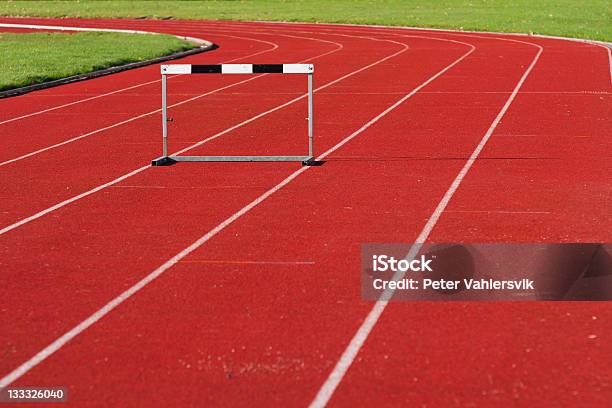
[161, 64, 314, 75]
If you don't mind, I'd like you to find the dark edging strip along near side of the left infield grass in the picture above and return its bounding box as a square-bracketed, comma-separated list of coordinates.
[0, 44, 219, 99]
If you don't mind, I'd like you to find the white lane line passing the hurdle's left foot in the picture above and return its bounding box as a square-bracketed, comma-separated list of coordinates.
[0, 34, 388, 235]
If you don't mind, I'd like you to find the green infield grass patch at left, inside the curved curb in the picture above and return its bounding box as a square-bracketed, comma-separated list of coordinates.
[0, 28, 195, 90]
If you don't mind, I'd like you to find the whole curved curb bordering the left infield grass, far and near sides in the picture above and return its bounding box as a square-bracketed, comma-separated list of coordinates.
[0, 24, 218, 98]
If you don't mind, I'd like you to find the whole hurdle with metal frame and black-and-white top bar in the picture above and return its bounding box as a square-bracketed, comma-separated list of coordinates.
[151, 64, 314, 166]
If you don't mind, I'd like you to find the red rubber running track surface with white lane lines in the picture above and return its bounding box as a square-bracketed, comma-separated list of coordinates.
[0, 18, 612, 407]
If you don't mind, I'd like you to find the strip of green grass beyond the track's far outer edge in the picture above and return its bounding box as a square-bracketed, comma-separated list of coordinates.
[0, 0, 612, 40]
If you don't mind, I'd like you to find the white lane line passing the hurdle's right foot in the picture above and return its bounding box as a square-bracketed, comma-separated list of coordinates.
[0, 34, 475, 388]
